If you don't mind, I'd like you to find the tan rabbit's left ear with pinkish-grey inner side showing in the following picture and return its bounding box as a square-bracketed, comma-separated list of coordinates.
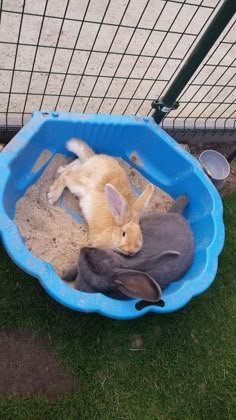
[105, 184, 127, 224]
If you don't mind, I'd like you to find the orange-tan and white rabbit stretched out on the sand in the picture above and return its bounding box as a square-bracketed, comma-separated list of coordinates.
[48, 139, 154, 255]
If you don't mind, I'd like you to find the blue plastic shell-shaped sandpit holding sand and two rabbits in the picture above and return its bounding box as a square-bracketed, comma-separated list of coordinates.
[0, 111, 225, 319]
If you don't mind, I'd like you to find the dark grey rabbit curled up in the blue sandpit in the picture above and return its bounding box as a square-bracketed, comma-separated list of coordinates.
[63, 195, 194, 302]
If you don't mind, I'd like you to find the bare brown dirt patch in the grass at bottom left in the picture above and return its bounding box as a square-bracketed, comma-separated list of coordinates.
[0, 330, 78, 398]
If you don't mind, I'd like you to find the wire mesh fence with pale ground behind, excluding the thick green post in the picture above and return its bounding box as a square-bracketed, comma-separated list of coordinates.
[0, 0, 236, 129]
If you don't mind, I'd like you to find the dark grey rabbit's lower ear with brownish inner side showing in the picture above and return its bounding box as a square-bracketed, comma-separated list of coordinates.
[113, 269, 162, 302]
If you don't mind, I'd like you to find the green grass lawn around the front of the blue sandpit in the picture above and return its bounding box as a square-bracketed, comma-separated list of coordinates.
[0, 194, 236, 420]
